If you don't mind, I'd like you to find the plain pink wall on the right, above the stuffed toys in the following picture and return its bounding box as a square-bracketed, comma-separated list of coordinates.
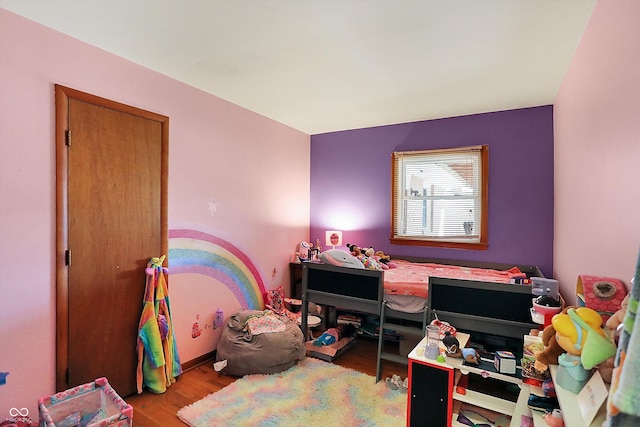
[554, 0, 640, 300]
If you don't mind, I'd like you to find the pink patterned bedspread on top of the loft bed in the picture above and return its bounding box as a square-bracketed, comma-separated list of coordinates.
[384, 260, 526, 298]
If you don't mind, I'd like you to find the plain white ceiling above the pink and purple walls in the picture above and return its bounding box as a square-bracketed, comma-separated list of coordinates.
[0, 0, 596, 134]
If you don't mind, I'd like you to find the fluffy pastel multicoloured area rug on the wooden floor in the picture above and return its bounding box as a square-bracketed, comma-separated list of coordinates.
[178, 357, 407, 427]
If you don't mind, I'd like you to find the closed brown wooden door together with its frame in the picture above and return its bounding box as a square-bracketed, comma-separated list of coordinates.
[56, 86, 168, 396]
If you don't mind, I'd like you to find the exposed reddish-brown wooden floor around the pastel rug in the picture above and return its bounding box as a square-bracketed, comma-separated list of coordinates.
[124, 338, 407, 427]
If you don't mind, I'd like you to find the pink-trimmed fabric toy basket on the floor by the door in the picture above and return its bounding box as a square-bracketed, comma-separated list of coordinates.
[38, 378, 133, 427]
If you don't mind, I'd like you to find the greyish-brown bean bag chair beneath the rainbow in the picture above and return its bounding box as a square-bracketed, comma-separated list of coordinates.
[216, 309, 306, 376]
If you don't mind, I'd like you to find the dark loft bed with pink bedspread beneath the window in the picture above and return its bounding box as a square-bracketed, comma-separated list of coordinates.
[302, 252, 543, 381]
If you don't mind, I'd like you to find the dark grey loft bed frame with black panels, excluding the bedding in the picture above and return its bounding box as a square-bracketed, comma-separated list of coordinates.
[301, 257, 544, 382]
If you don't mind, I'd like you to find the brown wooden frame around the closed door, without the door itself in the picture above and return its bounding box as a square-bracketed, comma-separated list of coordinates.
[55, 84, 169, 391]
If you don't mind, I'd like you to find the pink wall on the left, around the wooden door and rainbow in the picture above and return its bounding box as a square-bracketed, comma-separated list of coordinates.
[0, 9, 309, 419]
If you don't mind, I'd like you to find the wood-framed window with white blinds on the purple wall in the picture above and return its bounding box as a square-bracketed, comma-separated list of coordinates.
[391, 145, 489, 249]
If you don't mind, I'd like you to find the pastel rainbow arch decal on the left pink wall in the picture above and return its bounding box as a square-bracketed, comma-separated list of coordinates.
[169, 229, 265, 310]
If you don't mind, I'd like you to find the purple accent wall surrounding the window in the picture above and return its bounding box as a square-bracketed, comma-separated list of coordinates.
[309, 105, 554, 277]
